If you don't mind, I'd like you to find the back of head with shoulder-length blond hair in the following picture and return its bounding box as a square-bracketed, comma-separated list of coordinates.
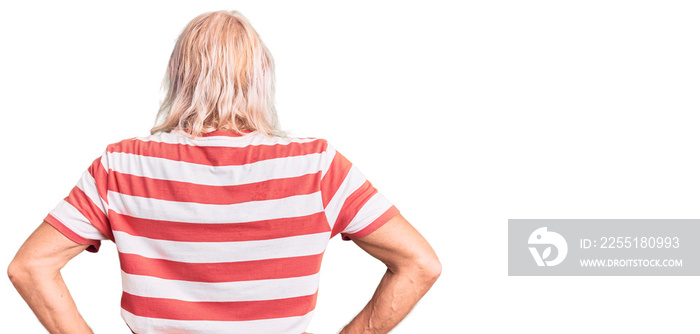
[151, 11, 282, 137]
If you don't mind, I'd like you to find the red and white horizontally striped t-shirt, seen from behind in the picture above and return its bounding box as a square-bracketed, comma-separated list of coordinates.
[45, 130, 398, 334]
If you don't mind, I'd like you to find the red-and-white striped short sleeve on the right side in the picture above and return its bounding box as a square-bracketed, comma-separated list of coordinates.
[321, 145, 399, 240]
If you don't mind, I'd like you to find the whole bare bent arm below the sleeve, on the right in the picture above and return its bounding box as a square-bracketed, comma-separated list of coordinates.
[340, 214, 442, 334]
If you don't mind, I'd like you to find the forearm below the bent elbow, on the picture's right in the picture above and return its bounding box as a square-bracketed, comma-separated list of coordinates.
[340, 270, 437, 334]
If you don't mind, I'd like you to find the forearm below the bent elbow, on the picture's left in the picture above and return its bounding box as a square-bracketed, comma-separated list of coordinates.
[12, 272, 92, 334]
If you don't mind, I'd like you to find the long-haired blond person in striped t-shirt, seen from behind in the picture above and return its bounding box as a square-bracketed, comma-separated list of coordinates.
[8, 12, 441, 334]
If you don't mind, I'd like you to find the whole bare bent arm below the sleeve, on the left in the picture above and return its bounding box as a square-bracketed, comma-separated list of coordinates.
[7, 222, 92, 334]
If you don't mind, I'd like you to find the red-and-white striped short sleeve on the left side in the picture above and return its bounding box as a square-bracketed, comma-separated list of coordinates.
[44, 152, 114, 252]
